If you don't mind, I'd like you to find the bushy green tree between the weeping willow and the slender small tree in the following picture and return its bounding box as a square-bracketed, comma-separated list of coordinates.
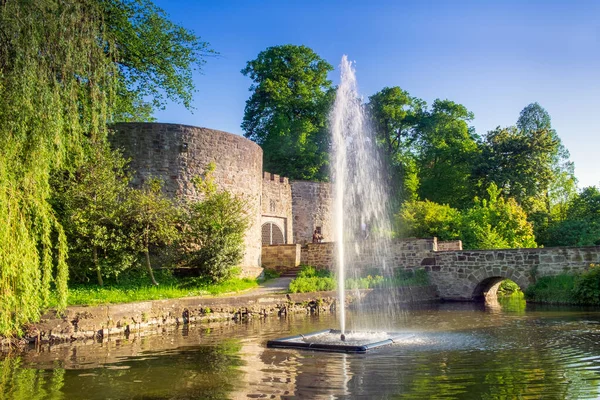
[53, 144, 133, 286]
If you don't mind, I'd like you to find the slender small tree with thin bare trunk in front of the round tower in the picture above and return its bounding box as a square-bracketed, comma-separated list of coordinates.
[127, 178, 179, 285]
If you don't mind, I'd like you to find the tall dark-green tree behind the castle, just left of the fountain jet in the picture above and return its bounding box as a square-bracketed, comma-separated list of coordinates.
[241, 45, 333, 180]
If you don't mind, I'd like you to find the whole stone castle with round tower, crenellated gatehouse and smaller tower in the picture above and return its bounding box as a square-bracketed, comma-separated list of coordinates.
[111, 122, 334, 267]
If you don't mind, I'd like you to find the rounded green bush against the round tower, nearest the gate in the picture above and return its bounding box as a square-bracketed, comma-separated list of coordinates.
[182, 164, 249, 282]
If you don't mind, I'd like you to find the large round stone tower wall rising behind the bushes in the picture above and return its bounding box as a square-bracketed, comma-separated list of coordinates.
[111, 123, 262, 266]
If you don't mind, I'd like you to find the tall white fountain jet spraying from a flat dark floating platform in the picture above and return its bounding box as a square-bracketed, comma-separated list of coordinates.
[267, 55, 406, 353]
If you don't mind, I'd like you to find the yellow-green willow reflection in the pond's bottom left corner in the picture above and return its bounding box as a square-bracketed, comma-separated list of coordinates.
[0, 356, 65, 400]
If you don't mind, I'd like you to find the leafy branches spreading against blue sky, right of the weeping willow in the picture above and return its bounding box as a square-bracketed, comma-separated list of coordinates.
[98, 0, 216, 121]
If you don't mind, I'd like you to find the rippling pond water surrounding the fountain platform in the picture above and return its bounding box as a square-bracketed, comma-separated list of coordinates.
[0, 299, 600, 400]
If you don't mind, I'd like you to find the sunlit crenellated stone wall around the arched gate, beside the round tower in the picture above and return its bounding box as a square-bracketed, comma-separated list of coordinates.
[261, 172, 294, 244]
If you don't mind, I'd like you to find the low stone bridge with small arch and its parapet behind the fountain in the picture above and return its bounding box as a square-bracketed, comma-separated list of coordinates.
[270, 238, 600, 300]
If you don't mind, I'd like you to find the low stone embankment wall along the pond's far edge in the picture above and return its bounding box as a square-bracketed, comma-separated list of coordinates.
[12, 286, 438, 343]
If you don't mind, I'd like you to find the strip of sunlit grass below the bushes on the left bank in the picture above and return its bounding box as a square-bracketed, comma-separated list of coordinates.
[50, 273, 259, 307]
